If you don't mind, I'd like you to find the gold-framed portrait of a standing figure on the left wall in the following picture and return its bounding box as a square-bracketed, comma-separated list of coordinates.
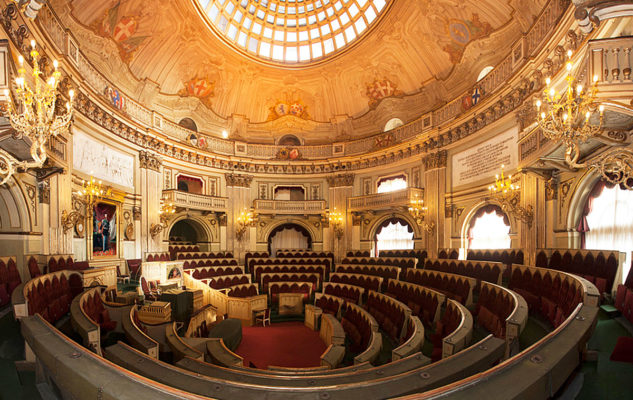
[92, 201, 120, 258]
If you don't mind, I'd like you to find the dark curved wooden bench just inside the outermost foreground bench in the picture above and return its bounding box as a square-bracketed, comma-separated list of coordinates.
[105, 335, 505, 400]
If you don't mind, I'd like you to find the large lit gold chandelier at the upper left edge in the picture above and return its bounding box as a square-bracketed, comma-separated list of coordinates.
[0, 40, 74, 184]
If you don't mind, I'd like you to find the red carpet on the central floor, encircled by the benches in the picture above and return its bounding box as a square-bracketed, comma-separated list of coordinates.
[235, 321, 326, 369]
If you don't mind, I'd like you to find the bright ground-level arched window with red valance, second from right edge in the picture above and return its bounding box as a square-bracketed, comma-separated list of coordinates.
[468, 204, 511, 249]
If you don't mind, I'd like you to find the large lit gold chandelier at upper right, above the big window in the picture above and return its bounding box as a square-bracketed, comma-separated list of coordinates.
[536, 50, 604, 168]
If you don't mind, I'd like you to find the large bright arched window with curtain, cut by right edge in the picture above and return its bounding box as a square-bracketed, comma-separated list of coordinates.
[578, 182, 633, 283]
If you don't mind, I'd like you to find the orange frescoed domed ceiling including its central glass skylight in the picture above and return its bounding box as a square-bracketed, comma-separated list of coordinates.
[50, 0, 546, 143]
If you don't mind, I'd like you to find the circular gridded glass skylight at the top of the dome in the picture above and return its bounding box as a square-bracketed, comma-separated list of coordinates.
[194, 0, 393, 64]
